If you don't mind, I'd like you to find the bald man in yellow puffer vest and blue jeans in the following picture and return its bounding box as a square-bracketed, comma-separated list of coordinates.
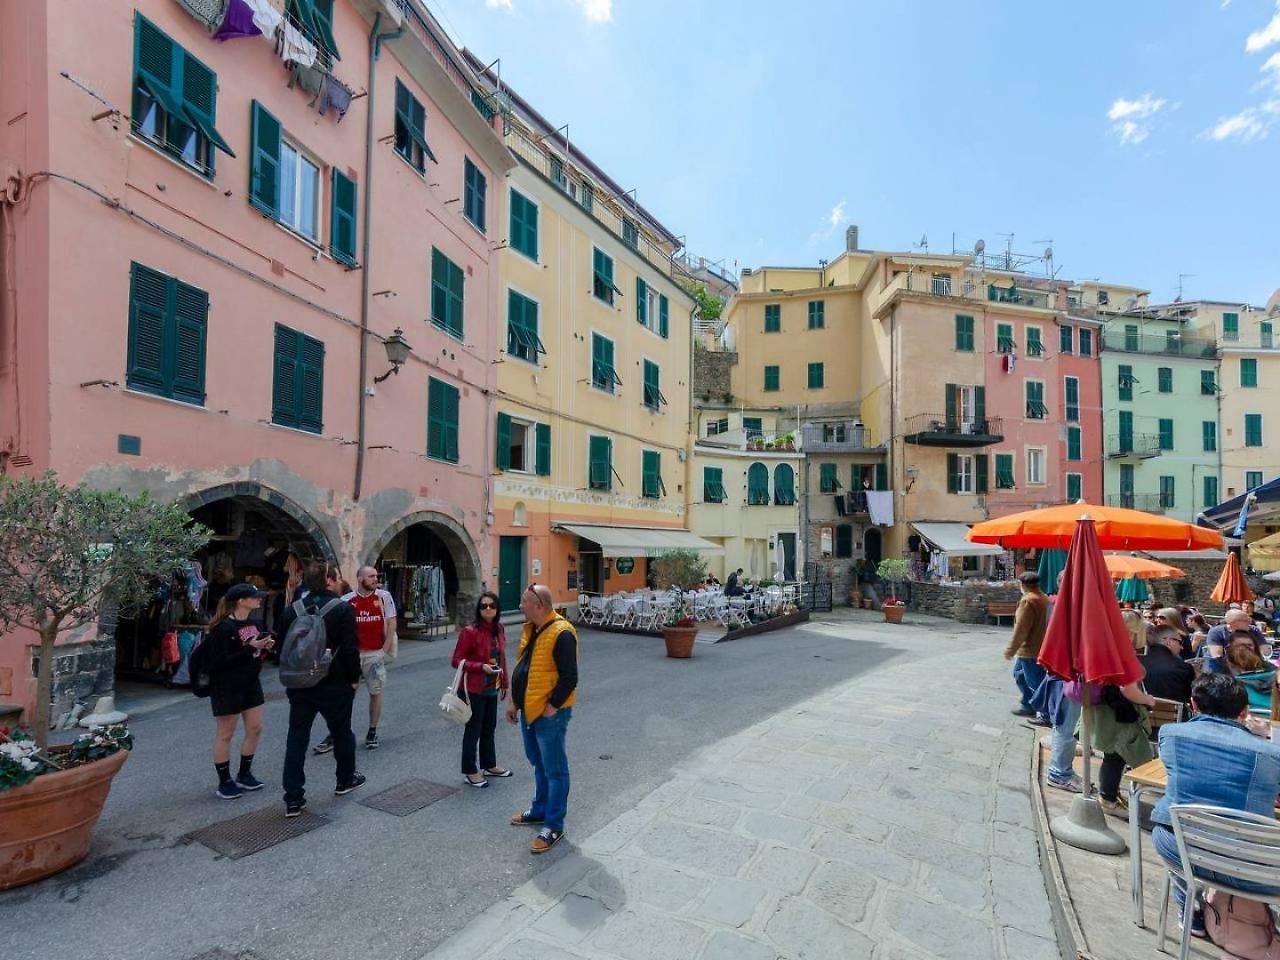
[507, 584, 577, 854]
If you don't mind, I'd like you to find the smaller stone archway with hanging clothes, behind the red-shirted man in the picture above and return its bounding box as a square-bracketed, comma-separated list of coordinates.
[365, 511, 484, 637]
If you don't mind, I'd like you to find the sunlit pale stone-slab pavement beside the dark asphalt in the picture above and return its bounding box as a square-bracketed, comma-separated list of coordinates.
[426, 613, 1060, 960]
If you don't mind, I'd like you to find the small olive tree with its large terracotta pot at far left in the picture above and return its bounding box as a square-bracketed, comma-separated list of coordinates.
[0, 474, 209, 890]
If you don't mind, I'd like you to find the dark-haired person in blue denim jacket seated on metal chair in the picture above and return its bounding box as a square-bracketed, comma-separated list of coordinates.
[1151, 673, 1280, 937]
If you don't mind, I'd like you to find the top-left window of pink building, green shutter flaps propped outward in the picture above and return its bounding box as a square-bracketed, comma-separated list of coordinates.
[131, 14, 236, 178]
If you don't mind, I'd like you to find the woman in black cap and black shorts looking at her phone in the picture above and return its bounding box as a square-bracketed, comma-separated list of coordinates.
[205, 584, 275, 800]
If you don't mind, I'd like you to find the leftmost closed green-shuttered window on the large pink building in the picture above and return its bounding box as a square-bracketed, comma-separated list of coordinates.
[125, 262, 209, 404]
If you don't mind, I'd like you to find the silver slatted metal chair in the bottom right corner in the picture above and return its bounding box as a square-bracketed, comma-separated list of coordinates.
[1162, 804, 1280, 960]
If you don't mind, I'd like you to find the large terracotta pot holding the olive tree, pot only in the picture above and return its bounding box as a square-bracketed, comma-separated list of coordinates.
[0, 750, 129, 890]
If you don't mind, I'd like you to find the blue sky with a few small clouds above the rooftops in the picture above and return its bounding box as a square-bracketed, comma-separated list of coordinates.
[428, 0, 1280, 305]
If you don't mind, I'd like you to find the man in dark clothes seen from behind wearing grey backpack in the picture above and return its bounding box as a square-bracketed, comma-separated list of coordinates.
[280, 561, 365, 817]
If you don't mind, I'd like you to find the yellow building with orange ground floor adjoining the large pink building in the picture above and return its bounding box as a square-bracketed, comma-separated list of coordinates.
[468, 62, 712, 611]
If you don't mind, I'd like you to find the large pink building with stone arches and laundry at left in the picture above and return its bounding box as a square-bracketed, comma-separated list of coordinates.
[0, 0, 513, 716]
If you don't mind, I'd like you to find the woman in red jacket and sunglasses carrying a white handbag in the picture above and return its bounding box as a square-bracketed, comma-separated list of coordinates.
[453, 591, 511, 787]
